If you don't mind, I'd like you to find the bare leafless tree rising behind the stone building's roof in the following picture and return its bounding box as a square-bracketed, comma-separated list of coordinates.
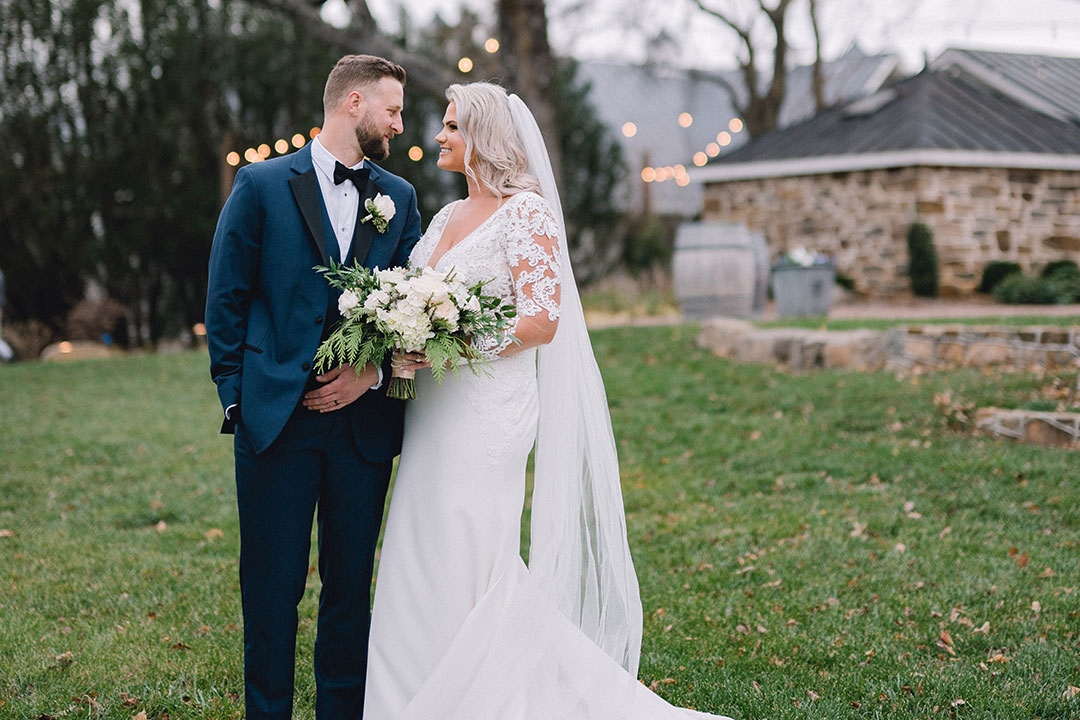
[690, 0, 825, 137]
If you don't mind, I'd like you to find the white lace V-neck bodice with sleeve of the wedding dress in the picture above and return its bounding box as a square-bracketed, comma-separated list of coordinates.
[409, 192, 562, 357]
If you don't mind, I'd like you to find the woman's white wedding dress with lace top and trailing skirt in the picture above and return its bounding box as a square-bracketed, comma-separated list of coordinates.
[364, 192, 734, 720]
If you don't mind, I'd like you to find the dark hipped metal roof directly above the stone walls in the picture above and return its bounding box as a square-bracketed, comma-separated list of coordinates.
[712, 69, 1080, 166]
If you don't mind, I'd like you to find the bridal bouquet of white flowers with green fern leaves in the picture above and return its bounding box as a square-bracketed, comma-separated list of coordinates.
[315, 261, 515, 399]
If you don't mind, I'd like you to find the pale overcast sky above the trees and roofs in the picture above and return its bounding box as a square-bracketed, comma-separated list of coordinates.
[324, 0, 1080, 70]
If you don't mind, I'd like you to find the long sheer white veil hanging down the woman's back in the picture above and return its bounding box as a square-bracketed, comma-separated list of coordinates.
[509, 95, 642, 679]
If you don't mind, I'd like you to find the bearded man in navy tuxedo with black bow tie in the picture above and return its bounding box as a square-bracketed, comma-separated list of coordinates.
[206, 55, 420, 720]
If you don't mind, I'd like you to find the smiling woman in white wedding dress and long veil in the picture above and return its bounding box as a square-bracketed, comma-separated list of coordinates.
[364, 83, 734, 720]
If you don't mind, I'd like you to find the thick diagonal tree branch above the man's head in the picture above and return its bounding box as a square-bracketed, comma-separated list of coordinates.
[248, 0, 455, 100]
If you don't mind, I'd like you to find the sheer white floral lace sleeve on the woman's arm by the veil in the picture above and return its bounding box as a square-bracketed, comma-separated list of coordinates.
[477, 192, 562, 357]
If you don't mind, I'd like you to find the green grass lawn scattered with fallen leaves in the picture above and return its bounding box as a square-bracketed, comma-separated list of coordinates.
[0, 326, 1080, 720]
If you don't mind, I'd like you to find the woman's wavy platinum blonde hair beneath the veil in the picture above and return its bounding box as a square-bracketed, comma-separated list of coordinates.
[446, 82, 540, 196]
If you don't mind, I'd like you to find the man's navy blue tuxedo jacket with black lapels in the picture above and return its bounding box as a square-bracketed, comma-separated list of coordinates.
[206, 145, 420, 462]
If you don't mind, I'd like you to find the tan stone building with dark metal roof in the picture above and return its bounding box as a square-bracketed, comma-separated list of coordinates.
[694, 51, 1080, 297]
